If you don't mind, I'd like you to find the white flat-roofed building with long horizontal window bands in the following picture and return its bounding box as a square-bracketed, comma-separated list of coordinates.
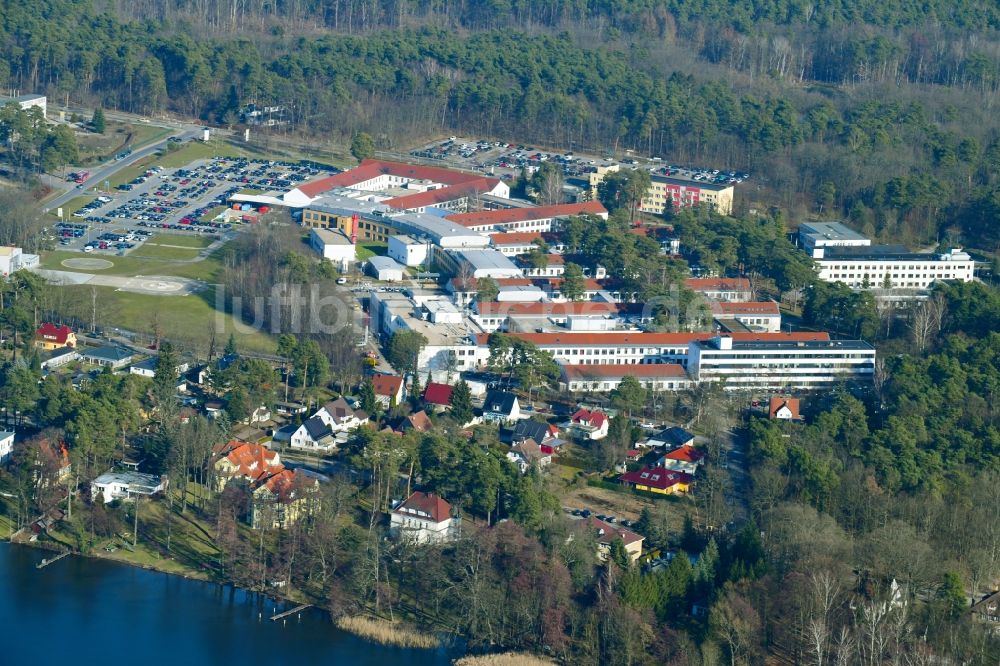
[687, 335, 875, 390]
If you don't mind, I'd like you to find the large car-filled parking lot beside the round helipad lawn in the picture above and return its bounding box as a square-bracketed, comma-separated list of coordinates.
[53, 157, 336, 255]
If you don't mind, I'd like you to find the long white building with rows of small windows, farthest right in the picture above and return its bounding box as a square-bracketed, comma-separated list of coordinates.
[812, 245, 975, 289]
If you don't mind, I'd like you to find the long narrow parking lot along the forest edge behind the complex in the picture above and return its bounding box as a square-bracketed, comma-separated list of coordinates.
[410, 137, 750, 185]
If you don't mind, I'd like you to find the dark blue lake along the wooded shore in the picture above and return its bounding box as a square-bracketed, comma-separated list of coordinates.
[0, 543, 450, 666]
